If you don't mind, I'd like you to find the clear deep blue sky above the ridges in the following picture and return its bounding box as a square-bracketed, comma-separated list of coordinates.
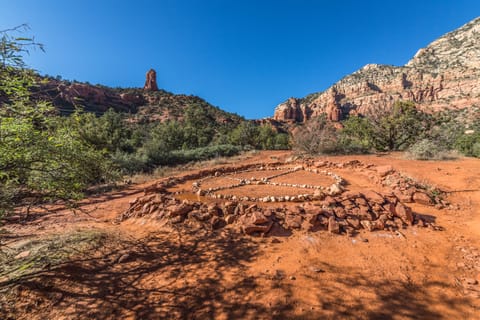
[0, 0, 480, 118]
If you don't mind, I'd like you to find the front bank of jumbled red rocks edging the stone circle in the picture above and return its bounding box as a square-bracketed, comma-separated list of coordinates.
[119, 186, 436, 235]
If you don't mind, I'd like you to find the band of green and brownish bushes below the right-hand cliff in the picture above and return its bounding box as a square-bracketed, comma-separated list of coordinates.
[294, 101, 480, 160]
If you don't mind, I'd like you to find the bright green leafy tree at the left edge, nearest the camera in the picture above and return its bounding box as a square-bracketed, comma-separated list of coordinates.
[0, 27, 113, 218]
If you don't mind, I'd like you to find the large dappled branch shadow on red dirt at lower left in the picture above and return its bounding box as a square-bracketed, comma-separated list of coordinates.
[0, 232, 284, 319]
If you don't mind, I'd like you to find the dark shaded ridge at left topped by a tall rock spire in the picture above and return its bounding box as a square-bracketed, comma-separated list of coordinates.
[31, 70, 244, 124]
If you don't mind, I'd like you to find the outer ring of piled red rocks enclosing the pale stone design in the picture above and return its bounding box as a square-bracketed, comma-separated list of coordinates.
[118, 161, 434, 235]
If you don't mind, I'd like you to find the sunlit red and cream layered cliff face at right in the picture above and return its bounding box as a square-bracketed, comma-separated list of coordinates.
[273, 18, 480, 122]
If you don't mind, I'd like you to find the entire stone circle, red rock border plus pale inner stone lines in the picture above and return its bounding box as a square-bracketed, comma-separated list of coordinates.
[117, 160, 445, 236]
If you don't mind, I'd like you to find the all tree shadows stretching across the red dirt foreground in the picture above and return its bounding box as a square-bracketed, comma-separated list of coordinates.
[0, 228, 469, 319]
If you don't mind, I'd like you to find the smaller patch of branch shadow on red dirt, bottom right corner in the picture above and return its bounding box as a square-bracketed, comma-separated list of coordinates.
[290, 264, 475, 319]
